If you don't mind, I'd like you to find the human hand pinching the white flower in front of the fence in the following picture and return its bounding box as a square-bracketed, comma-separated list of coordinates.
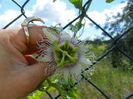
[0, 26, 55, 99]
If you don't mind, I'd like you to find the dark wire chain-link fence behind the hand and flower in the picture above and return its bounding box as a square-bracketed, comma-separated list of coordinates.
[3, 0, 133, 99]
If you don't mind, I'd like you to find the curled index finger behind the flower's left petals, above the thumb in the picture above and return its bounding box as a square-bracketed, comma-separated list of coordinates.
[11, 26, 44, 54]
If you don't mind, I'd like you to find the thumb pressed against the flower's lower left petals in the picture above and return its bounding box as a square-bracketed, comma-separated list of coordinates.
[13, 62, 55, 96]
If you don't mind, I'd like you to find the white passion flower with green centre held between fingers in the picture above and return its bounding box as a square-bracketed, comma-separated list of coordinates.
[34, 27, 91, 79]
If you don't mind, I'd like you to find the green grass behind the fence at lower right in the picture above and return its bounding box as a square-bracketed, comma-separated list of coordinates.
[78, 60, 133, 99]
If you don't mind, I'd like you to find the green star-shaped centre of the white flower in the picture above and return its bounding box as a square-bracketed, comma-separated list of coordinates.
[53, 41, 78, 67]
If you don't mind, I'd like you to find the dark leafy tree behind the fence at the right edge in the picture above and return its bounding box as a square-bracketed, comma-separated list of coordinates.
[104, 0, 133, 69]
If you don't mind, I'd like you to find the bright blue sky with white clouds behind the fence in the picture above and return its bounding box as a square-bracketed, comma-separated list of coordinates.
[0, 0, 126, 39]
